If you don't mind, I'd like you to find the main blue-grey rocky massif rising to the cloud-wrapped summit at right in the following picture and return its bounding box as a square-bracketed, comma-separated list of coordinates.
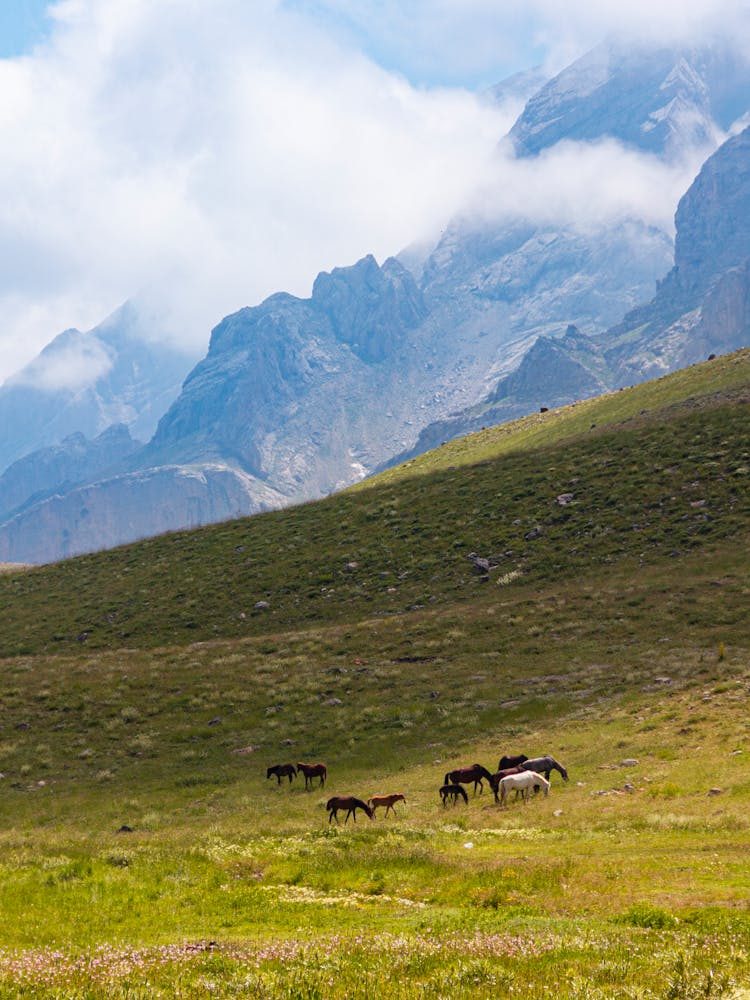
[5, 37, 750, 562]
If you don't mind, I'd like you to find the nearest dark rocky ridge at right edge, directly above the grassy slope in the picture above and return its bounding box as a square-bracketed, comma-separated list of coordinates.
[402, 121, 750, 464]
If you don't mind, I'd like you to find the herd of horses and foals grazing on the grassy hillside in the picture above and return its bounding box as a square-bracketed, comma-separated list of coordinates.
[266, 754, 568, 823]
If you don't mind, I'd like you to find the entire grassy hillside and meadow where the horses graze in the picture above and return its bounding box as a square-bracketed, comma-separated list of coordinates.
[0, 352, 750, 1000]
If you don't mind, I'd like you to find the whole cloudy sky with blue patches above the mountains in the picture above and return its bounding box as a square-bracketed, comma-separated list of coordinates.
[0, 0, 747, 378]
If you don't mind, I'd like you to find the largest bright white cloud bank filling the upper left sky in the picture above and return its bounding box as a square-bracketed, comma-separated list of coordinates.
[0, 0, 518, 375]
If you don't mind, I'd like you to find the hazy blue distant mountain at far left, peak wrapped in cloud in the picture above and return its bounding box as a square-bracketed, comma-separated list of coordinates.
[0, 303, 196, 470]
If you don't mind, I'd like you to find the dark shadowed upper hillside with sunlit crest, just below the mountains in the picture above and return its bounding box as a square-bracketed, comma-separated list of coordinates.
[0, 351, 750, 655]
